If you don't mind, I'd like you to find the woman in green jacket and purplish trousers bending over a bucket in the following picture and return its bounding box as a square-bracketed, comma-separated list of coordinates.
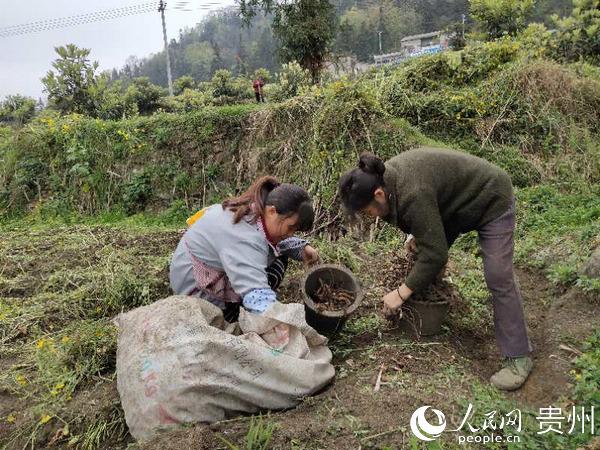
[339, 147, 533, 390]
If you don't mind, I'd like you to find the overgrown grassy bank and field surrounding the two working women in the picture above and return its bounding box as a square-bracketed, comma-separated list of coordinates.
[0, 39, 600, 449]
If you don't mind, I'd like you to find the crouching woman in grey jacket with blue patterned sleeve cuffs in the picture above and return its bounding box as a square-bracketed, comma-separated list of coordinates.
[170, 177, 318, 322]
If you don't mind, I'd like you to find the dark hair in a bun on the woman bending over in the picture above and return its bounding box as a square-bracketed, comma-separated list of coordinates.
[339, 153, 385, 212]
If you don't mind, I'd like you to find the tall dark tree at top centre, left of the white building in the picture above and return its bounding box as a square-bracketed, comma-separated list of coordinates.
[240, 0, 337, 83]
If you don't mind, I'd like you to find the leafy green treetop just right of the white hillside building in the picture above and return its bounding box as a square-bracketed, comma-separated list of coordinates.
[470, 0, 535, 40]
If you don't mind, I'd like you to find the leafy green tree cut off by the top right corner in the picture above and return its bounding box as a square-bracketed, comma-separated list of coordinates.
[553, 0, 600, 63]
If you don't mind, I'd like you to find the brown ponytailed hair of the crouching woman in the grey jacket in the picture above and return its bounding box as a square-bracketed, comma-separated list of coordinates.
[221, 176, 315, 231]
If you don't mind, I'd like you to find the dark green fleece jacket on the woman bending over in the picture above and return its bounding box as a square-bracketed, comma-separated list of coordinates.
[384, 147, 513, 291]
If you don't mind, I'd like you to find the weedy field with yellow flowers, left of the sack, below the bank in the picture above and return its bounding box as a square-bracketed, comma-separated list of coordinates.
[0, 227, 179, 449]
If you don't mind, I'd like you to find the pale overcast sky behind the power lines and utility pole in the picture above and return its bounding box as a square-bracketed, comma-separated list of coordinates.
[0, 0, 234, 99]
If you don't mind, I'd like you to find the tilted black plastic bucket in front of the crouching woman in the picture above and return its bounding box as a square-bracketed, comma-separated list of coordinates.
[302, 264, 363, 335]
